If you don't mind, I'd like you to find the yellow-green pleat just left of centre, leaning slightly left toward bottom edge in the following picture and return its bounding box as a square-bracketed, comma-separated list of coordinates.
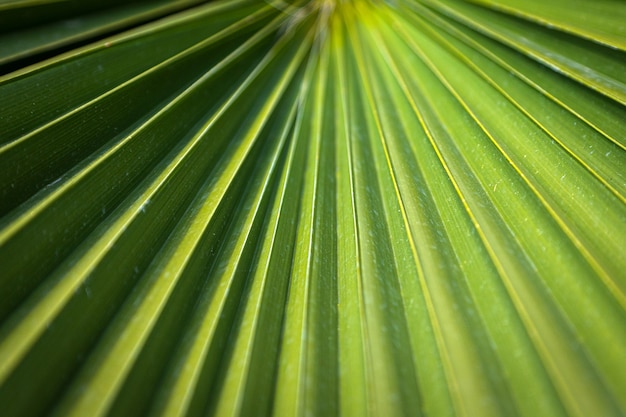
[274, 14, 335, 415]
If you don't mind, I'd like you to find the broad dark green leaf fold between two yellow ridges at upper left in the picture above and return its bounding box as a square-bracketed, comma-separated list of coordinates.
[0, 0, 271, 158]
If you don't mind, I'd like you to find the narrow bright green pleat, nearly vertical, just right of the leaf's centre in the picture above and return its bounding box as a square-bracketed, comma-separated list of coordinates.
[329, 17, 371, 416]
